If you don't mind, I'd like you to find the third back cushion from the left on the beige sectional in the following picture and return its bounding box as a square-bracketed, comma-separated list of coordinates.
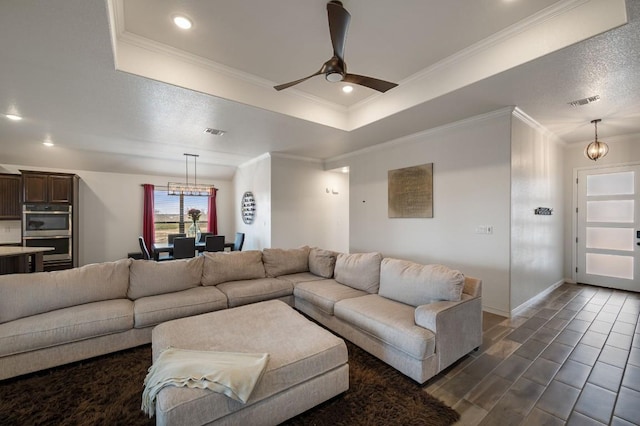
[202, 250, 265, 285]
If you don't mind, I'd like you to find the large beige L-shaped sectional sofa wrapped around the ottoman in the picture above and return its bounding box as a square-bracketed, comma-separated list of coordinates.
[0, 247, 482, 383]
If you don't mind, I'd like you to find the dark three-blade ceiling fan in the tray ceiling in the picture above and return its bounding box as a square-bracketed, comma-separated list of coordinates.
[274, 0, 397, 93]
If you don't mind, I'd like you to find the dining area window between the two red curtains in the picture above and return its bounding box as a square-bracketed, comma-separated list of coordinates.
[153, 189, 209, 243]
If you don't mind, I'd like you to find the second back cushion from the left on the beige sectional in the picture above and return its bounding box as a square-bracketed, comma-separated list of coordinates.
[127, 256, 204, 300]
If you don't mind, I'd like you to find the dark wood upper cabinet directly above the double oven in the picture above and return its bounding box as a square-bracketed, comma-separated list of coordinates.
[22, 171, 74, 204]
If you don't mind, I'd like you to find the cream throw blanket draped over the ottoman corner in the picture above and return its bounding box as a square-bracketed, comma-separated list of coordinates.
[142, 348, 269, 417]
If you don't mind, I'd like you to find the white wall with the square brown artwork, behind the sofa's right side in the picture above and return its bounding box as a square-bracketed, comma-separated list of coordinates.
[328, 109, 512, 315]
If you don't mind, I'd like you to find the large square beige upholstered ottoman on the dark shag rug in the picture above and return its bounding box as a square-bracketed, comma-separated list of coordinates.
[152, 300, 349, 426]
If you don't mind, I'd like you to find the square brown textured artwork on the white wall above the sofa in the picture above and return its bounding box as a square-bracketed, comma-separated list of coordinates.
[388, 163, 433, 218]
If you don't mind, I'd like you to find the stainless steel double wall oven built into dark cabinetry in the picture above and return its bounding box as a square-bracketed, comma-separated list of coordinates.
[22, 204, 73, 261]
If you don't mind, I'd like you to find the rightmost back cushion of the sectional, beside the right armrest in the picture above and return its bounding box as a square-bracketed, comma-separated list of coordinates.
[379, 258, 464, 306]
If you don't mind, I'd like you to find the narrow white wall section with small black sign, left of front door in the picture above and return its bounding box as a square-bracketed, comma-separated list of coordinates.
[510, 111, 565, 311]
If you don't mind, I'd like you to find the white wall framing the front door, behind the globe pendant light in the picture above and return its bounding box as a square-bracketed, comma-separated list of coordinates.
[563, 133, 640, 278]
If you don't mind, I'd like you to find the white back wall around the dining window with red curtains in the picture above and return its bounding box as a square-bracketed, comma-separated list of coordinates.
[1, 165, 235, 265]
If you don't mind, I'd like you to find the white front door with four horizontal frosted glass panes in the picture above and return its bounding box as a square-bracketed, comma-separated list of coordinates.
[576, 165, 640, 291]
